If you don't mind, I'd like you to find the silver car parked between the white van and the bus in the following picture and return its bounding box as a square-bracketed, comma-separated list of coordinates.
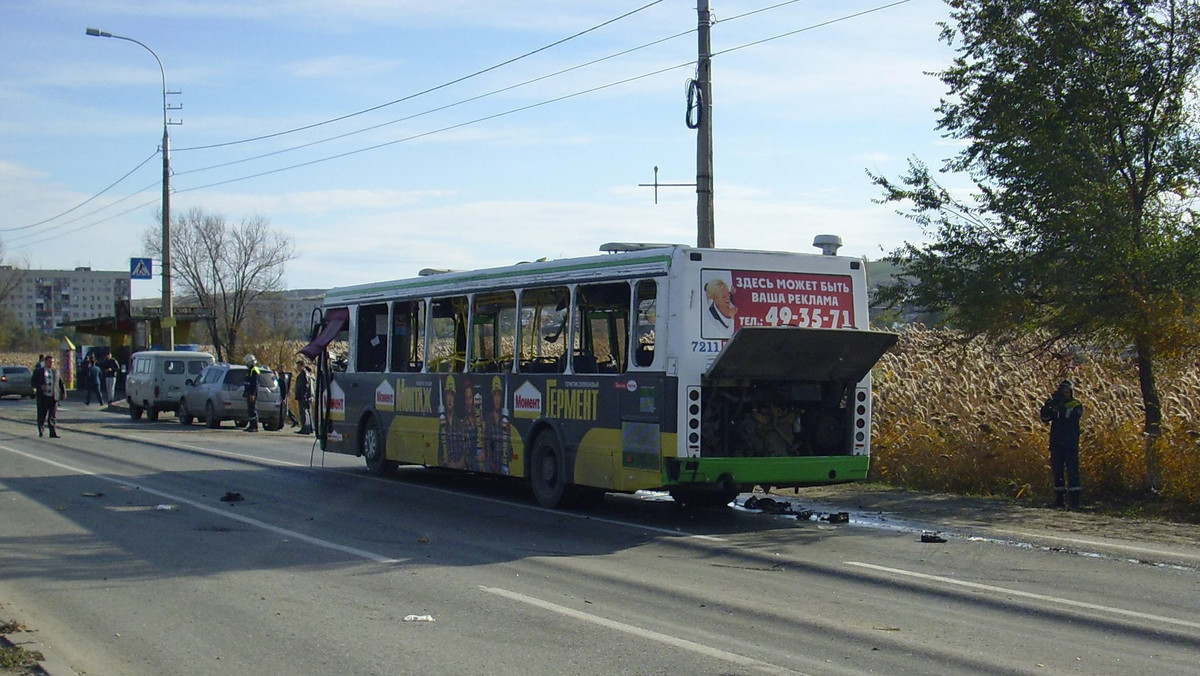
[179, 364, 284, 430]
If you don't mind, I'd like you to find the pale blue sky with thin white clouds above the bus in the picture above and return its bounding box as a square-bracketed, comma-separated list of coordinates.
[0, 0, 956, 297]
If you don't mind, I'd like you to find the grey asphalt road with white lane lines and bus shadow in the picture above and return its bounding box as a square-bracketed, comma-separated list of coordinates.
[0, 400, 1200, 676]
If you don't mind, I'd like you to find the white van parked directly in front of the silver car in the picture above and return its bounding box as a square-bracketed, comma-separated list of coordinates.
[125, 349, 216, 423]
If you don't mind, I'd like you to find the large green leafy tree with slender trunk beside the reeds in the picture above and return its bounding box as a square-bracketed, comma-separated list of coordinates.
[871, 0, 1200, 487]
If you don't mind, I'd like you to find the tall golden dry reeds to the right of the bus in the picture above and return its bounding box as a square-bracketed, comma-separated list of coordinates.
[871, 327, 1200, 515]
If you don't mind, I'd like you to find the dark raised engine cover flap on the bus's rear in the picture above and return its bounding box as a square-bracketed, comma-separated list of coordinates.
[706, 327, 900, 383]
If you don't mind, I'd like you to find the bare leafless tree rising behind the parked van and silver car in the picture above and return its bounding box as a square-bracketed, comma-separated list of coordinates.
[142, 208, 295, 361]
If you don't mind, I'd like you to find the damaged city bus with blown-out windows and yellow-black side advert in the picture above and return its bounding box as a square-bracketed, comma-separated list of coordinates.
[301, 235, 896, 507]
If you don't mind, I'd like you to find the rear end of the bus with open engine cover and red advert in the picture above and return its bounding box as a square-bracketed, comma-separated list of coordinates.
[664, 240, 898, 503]
